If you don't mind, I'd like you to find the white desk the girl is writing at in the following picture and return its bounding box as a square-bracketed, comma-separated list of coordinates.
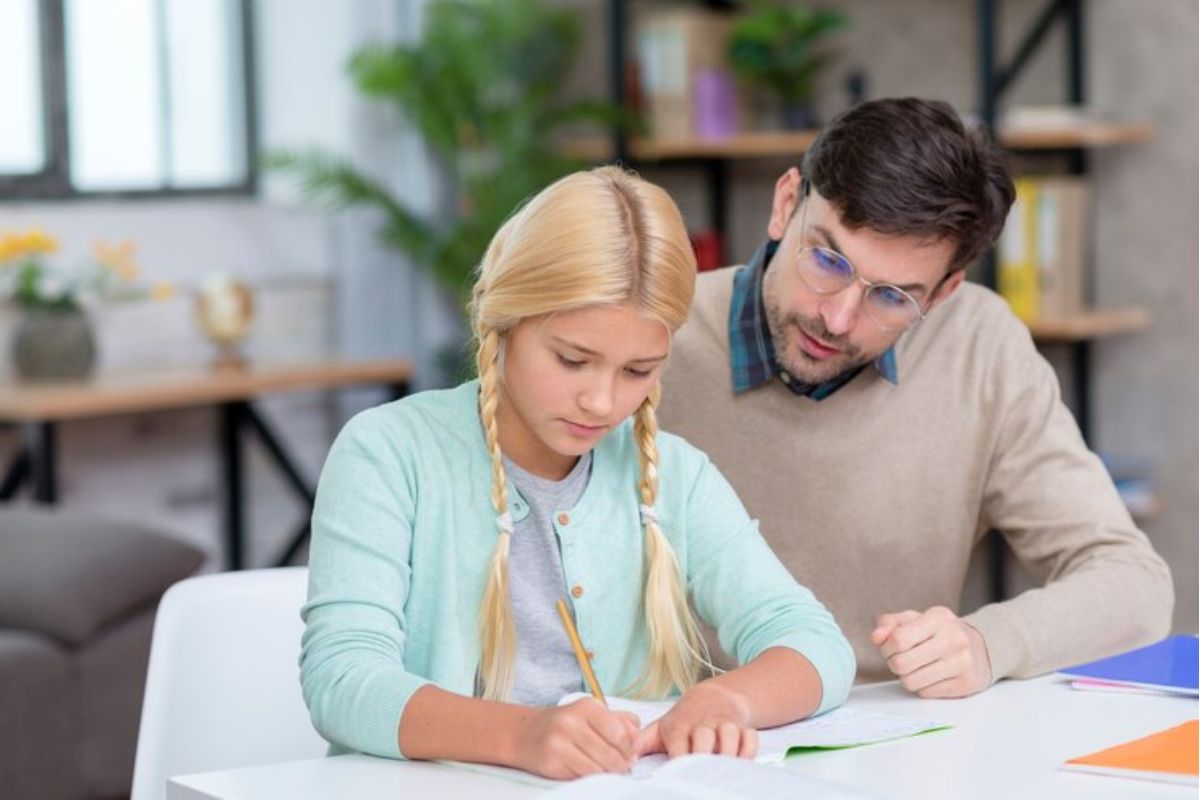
[167, 676, 1200, 800]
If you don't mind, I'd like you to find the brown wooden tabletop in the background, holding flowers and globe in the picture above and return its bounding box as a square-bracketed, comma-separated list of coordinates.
[0, 359, 413, 422]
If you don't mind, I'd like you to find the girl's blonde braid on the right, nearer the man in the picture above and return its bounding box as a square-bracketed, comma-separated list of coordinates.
[634, 386, 708, 697]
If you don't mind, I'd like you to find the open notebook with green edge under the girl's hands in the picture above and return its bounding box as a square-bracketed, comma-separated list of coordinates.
[559, 693, 950, 776]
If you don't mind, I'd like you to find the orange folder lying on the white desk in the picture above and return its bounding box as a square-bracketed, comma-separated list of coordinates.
[1062, 720, 1200, 784]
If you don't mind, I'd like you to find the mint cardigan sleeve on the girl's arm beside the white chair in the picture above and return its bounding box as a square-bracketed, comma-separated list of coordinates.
[300, 409, 428, 758]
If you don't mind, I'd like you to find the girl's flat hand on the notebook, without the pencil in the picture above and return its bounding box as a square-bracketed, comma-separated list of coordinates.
[637, 681, 758, 758]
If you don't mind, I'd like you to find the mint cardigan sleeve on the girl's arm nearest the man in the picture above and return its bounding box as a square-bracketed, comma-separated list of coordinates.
[686, 448, 854, 714]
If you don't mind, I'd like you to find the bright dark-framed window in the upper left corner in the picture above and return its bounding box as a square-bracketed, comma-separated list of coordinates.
[0, 0, 254, 197]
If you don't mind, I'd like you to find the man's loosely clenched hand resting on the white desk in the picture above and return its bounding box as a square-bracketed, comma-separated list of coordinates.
[871, 606, 991, 698]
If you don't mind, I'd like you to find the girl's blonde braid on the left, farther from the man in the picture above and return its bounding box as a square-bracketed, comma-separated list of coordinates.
[476, 327, 517, 700]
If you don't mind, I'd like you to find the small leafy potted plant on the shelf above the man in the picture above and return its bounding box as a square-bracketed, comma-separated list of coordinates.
[728, 0, 850, 130]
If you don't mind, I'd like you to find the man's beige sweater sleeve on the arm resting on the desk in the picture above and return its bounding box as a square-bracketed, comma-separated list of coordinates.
[965, 321, 1174, 680]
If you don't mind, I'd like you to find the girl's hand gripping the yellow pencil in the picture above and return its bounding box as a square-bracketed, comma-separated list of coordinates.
[514, 697, 641, 780]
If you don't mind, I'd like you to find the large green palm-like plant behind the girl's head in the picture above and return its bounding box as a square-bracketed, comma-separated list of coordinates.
[265, 0, 629, 309]
